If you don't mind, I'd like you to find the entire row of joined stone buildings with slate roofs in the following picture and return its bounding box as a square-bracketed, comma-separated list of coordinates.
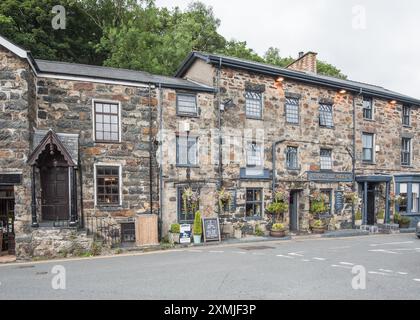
[0, 32, 420, 258]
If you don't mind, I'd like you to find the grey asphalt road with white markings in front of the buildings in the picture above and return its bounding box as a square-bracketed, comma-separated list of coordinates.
[0, 234, 420, 300]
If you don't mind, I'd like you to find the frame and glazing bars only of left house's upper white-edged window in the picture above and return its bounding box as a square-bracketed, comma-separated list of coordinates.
[93, 100, 121, 143]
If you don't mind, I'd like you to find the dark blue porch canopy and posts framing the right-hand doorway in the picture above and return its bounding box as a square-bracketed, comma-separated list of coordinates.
[356, 174, 393, 224]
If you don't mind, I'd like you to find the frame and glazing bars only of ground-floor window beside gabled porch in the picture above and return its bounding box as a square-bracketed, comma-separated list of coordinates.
[95, 165, 121, 207]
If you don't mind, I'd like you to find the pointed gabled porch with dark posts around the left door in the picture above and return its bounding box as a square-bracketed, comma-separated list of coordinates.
[27, 129, 77, 227]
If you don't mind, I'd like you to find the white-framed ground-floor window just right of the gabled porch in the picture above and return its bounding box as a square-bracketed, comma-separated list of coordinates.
[94, 163, 122, 207]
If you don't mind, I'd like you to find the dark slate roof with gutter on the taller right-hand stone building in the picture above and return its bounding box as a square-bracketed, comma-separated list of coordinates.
[175, 51, 420, 106]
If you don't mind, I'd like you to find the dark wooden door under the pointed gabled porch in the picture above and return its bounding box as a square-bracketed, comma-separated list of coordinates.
[41, 167, 70, 221]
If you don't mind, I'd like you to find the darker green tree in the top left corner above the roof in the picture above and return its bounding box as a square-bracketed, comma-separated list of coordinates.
[0, 0, 103, 64]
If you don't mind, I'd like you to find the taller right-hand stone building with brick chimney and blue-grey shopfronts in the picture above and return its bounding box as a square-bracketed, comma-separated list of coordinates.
[176, 52, 420, 232]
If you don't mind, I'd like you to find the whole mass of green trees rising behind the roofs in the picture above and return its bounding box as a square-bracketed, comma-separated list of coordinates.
[0, 0, 345, 78]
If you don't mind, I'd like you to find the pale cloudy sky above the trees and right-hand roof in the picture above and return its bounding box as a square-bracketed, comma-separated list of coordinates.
[156, 0, 420, 98]
